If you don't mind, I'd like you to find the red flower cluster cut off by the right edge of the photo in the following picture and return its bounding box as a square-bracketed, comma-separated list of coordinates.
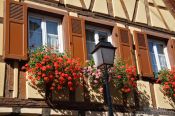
[157, 67, 175, 99]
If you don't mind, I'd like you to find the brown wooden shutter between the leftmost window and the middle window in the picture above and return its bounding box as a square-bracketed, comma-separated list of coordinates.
[69, 17, 86, 64]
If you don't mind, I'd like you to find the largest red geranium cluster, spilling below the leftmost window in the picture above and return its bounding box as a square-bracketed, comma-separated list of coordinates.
[23, 47, 82, 91]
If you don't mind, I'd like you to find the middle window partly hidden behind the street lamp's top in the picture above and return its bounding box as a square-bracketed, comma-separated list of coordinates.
[86, 25, 112, 60]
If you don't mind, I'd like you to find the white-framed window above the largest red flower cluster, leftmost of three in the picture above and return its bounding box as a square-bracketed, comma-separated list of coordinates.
[28, 14, 63, 52]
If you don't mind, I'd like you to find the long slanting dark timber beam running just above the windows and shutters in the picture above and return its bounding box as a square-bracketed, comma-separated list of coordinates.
[25, 0, 175, 36]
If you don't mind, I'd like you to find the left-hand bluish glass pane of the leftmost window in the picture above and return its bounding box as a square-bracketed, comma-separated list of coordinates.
[29, 17, 42, 49]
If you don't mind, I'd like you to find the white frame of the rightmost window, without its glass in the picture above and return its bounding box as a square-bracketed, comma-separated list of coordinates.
[148, 38, 171, 73]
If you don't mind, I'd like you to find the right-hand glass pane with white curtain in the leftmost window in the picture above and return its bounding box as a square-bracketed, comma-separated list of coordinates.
[46, 21, 59, 49]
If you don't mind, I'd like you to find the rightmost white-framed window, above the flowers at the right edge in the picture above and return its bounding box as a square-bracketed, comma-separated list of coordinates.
[148, 39, 170, 73]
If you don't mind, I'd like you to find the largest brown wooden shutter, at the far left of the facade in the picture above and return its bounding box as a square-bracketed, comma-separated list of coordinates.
[4, 0, 27, 60]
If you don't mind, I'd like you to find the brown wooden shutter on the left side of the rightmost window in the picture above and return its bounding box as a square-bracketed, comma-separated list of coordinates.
[134, 31, 154, 77]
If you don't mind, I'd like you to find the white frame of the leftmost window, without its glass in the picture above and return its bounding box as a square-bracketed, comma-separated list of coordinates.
[28, 13, 64, 52]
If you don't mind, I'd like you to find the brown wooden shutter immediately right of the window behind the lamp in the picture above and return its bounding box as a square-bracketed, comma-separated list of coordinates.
[118, 27, 134, 65]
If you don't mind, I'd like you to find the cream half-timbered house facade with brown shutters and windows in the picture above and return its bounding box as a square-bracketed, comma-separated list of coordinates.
[0, 0, 175, 116]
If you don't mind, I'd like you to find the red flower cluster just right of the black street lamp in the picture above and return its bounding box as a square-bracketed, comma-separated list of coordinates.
[111, 60, 137, 94]
